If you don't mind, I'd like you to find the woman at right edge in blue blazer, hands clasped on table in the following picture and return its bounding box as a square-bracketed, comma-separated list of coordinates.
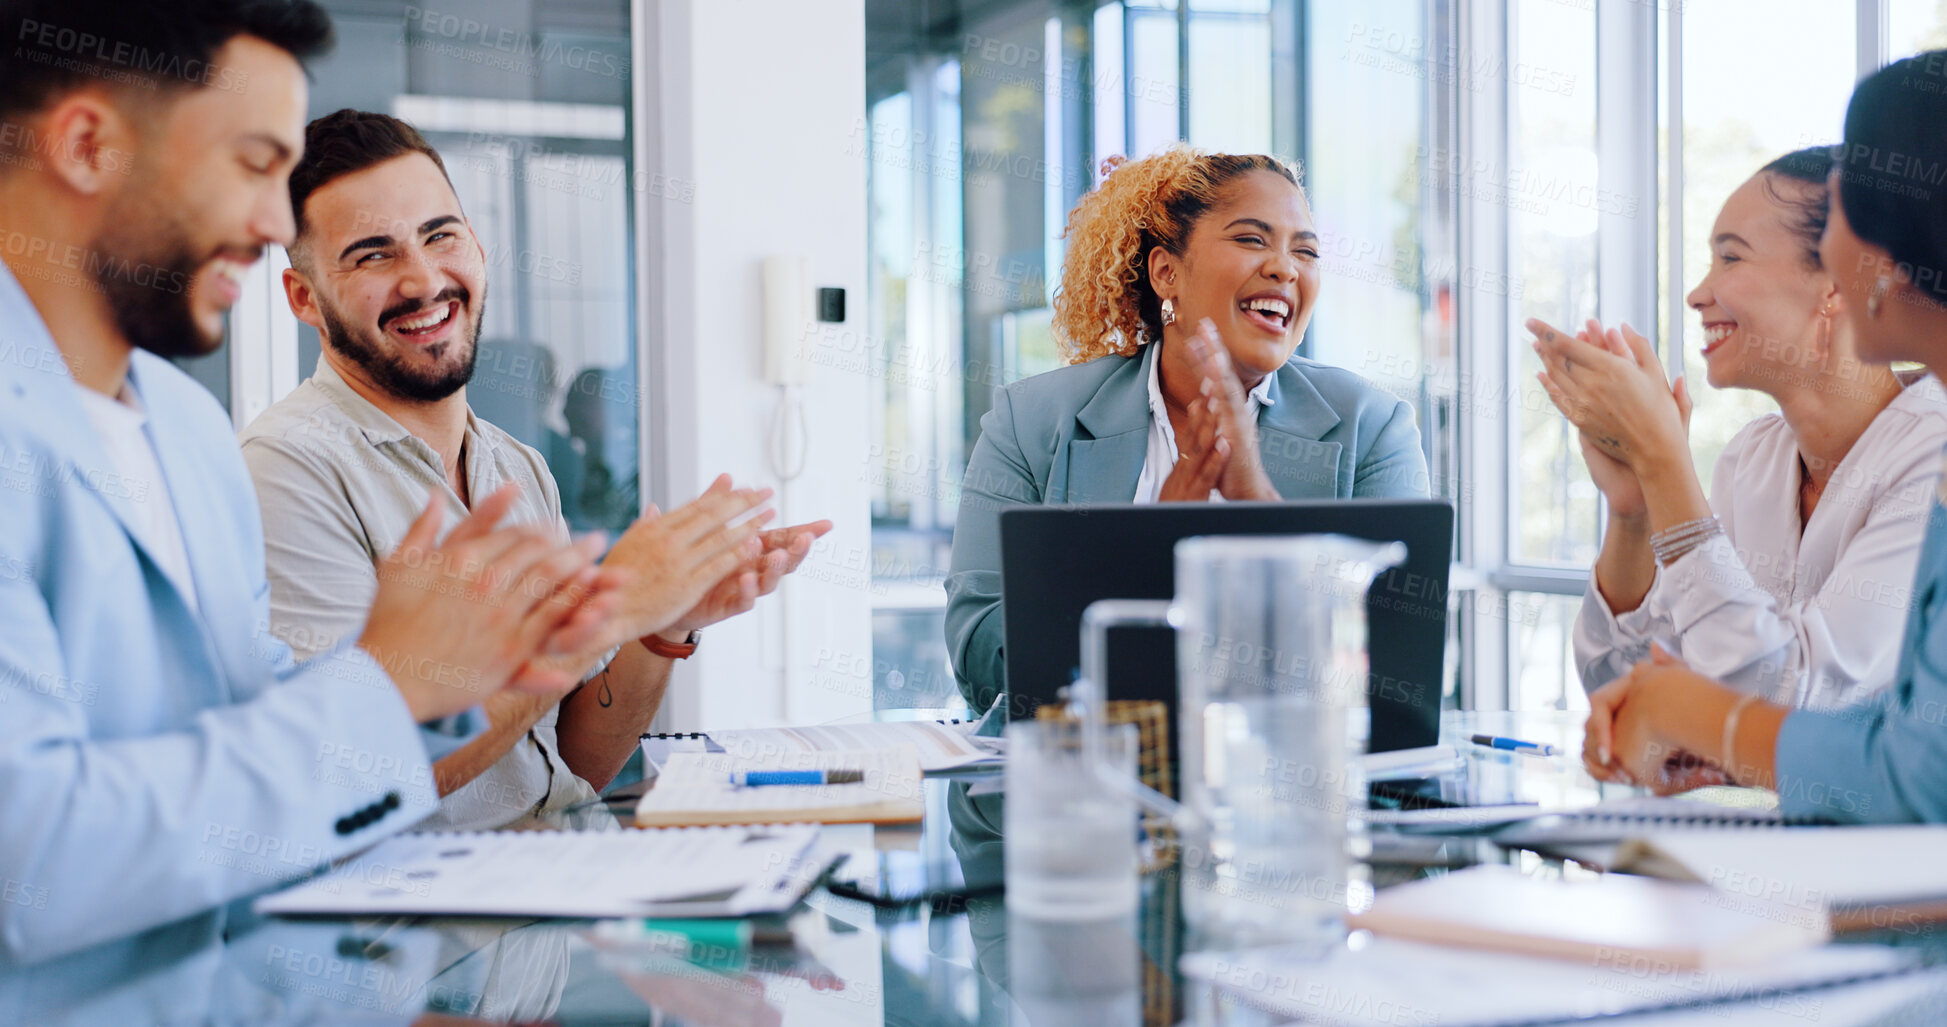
[1583, 51, 1947, 822]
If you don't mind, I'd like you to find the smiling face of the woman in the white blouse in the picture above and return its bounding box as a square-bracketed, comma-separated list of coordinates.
[1688, 171, 1840, 390]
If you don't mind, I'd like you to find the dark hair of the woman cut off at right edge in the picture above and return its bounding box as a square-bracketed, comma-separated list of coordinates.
[1836, 51, 1947, 304]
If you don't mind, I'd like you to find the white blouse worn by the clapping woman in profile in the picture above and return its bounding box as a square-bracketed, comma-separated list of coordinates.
[1645, 417, 1943, 709]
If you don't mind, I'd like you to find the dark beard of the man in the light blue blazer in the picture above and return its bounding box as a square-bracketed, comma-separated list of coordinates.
[90, 189, 225, 359]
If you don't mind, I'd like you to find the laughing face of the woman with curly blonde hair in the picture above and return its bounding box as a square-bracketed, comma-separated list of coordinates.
[1151, 170, 1318, 382]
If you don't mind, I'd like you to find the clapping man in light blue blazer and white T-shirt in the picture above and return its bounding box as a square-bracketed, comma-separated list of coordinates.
[0, 0, 615, 989]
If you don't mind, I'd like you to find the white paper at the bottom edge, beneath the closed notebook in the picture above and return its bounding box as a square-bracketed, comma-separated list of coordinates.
[1182, 935, 1918, 1027]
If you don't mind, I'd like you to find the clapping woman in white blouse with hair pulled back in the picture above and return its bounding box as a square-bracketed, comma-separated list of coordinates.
[1528, 148, 1947, 709]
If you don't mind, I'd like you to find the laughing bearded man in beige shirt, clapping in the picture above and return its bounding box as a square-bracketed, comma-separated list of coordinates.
[243, 111, 831, 828]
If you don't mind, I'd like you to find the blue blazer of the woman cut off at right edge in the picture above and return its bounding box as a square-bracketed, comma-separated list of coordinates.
[1778, 494, 1947, 824]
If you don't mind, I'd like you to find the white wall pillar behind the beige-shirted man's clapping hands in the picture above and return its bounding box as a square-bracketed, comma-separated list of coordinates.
[637, 0, 872, 731]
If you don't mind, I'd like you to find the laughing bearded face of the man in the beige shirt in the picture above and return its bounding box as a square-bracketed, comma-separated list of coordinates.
[284, 152, 487, 403]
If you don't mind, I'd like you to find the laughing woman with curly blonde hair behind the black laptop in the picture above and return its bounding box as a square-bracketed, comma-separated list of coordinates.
[946, 144, 1427, 709]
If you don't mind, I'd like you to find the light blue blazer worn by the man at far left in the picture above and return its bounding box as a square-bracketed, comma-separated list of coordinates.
[0, 348, 436, 970]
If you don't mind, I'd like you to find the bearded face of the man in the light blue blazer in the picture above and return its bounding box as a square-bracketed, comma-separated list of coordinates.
[92, 35, 306, 357]
